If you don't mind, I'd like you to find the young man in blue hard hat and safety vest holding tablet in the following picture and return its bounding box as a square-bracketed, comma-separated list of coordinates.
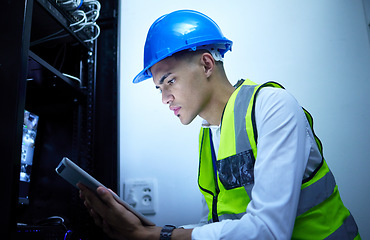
[79, 10, 360, 240]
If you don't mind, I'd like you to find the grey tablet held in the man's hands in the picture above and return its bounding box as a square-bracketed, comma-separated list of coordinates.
[55, 157, 155, 226]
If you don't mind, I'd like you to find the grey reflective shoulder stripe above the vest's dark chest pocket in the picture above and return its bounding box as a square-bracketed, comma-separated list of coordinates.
[234, 85, 255, 153]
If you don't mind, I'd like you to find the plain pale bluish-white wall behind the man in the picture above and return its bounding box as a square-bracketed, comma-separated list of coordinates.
[120, 0, 370, 239]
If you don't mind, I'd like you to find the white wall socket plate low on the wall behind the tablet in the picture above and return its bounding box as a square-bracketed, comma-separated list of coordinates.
[124, 178, 158, 215]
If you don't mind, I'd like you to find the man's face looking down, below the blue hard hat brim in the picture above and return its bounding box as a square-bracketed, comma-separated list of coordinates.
[151, 57, 211, 125]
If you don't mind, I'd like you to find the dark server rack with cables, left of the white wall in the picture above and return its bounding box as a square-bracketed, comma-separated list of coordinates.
[0, 0, 118, 239]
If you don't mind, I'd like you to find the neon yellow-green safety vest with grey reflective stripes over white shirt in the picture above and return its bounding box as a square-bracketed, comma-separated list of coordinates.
[198, 80, 360, 239]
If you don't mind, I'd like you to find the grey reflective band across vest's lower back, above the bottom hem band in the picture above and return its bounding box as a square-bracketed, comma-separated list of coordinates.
[297, 170, 336, 216]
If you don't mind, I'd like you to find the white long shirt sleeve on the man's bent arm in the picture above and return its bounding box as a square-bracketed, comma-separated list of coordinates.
[192, 87, 313, 240]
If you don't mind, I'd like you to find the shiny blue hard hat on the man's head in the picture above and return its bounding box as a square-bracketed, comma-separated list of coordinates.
[133, 10, 232, 83]
